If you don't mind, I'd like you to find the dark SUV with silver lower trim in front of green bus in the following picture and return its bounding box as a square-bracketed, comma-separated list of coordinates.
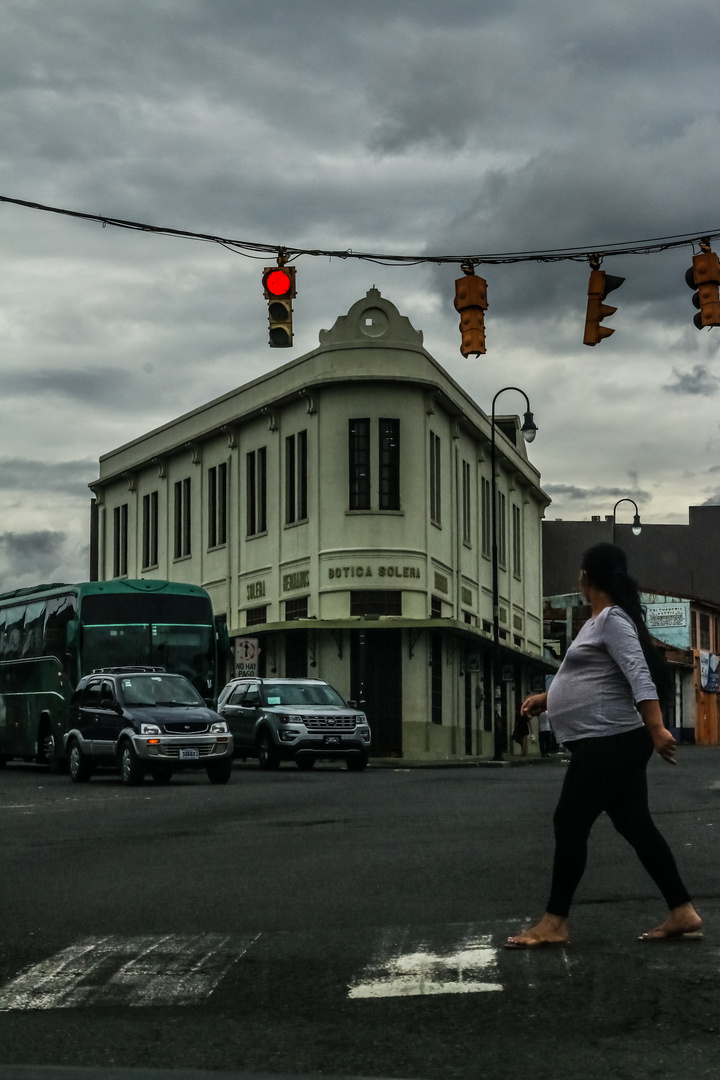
[65, 667, 233, 785]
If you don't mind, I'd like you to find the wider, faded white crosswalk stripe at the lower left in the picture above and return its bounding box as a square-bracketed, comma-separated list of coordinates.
[0, 933, 260, 1012]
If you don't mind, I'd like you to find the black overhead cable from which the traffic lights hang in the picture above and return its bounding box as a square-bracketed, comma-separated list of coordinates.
[0, 195, 720, 266]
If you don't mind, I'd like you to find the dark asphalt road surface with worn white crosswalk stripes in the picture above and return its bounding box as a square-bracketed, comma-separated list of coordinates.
[0, 748, 720, 1080]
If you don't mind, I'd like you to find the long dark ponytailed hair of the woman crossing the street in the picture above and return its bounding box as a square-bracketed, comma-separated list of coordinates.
[580, 543, 673, 704]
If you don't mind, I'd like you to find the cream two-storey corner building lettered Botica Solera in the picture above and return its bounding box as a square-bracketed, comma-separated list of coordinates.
[91, 288, 549, 759]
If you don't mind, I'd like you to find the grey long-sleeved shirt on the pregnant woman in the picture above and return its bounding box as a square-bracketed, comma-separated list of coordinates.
[547, 607, 657, 742]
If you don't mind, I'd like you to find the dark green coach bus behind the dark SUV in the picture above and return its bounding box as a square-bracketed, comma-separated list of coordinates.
[0, 579, 221, 769]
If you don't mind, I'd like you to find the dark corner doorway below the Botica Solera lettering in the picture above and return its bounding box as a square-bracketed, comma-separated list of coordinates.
[350, 630, 403, 756]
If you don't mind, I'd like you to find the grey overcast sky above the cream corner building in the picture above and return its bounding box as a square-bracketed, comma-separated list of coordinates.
[0, 0, 720, 590]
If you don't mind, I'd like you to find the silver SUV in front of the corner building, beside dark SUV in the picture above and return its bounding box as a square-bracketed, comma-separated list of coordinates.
[217, 678, 370, 771]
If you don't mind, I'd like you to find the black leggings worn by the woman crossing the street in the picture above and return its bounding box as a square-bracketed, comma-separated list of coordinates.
[547, 727, 690, 918]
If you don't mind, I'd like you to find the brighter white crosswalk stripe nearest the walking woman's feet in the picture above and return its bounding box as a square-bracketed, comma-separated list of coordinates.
[348, 935, 503, 998]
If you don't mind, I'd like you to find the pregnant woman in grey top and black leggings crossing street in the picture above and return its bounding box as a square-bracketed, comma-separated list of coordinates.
[506, 543, 703, 948]
